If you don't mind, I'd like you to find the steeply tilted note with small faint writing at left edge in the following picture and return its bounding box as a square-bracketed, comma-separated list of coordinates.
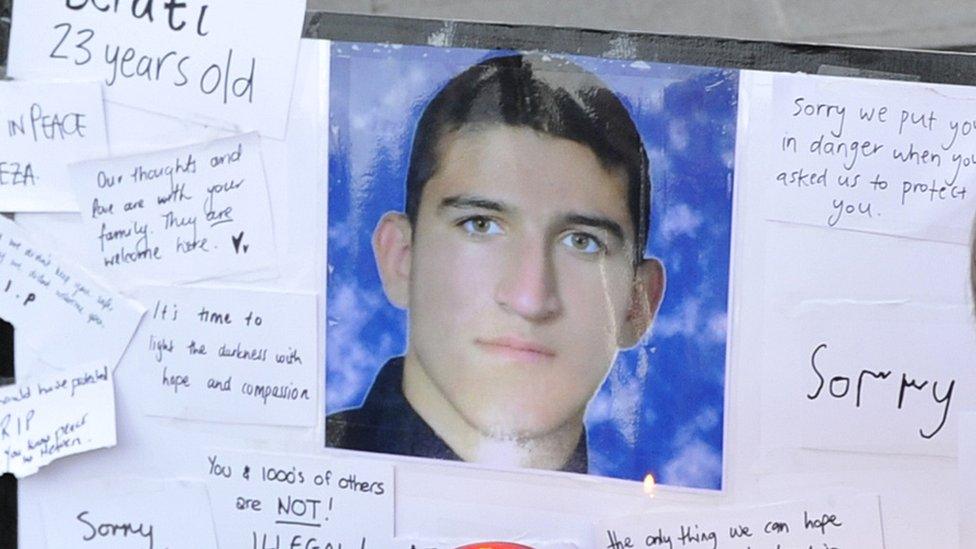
[0, 217, 143, 368]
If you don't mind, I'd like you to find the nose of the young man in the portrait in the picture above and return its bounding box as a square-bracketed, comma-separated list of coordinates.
[495, 239, 562, 322]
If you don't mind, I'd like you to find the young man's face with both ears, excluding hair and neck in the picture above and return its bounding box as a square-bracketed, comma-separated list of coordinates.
[374, 125, 663, 439]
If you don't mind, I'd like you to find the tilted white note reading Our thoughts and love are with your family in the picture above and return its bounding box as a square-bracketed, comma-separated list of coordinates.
[69, 133, 274, 282]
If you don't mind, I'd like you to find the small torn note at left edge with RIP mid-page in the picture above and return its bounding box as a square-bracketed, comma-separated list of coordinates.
[0, 366, 115, 478]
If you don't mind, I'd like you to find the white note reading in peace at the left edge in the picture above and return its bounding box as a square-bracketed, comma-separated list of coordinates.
[0, 82, 108, 212]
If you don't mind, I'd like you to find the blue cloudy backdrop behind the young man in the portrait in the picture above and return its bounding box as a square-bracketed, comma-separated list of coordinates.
[326, 42, 738, 489]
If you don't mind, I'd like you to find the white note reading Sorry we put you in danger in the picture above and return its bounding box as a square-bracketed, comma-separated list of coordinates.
[741, 73, 976, 244]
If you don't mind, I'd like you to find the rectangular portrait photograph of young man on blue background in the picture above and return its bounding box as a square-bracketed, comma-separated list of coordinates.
[324, 42, 738, 490]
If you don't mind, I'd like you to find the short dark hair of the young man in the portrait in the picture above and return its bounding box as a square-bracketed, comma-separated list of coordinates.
[406, 54, 651, 262]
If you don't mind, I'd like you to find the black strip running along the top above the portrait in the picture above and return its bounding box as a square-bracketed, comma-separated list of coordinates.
[304, 11, 976, 84]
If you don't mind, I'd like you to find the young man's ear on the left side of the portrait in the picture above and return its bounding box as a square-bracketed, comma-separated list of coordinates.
[373, 212, 412, 309]
